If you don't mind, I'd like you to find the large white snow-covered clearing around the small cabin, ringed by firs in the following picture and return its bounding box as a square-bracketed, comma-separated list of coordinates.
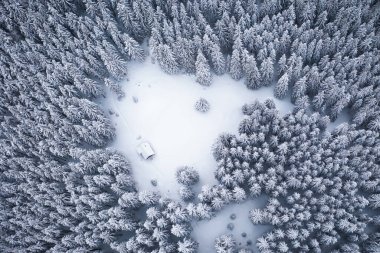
[103, 59, 292, 199]
